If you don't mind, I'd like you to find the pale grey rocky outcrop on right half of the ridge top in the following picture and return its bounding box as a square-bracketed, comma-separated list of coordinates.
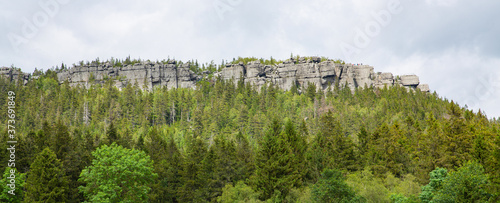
[216, 58, 429, 92]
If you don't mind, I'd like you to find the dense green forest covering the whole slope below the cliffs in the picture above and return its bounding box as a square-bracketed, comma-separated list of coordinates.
[0, 58, 500, 203]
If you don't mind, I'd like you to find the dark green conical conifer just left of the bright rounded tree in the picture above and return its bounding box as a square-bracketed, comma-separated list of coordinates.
[24, 147, 68, 202]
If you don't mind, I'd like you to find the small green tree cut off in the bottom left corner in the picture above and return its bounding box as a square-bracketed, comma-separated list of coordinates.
[0, 167, 26, 203]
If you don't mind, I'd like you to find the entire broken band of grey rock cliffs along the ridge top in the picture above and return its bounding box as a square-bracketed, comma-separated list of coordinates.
[0, 57, 429, 92]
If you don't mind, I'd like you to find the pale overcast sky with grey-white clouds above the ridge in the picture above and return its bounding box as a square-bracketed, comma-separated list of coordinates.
[0, 0, 500, 118]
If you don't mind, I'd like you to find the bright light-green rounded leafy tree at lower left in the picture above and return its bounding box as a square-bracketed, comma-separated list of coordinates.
[79, 143, 158, 202]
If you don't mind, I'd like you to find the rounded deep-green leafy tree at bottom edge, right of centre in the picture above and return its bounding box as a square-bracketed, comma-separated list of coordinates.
[312, 169, 366, 202]
